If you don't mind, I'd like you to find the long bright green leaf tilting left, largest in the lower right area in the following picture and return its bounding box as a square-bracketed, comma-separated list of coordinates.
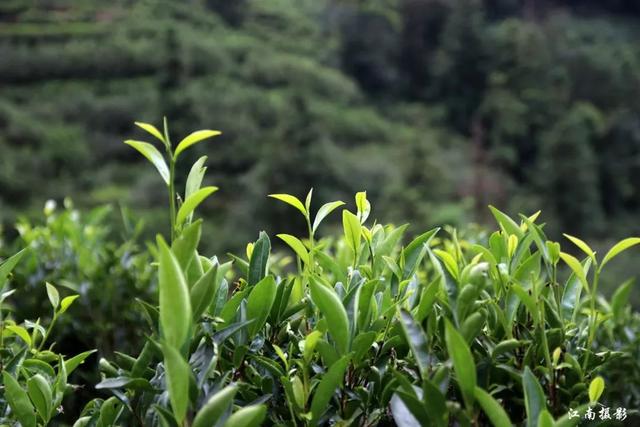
[445, 320, 477, 407]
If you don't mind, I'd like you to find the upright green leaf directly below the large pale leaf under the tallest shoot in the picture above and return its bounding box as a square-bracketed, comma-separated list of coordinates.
[162, 343, 192, 425]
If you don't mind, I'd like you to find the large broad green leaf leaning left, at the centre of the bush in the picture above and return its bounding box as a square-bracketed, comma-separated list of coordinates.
[309, 277, 350, 355]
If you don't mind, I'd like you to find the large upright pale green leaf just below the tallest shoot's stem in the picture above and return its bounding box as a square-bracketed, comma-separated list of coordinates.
[158, 236, 192, 348]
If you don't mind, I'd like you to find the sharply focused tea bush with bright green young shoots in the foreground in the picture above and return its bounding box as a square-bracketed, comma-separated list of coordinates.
[0, 122, 640, 427]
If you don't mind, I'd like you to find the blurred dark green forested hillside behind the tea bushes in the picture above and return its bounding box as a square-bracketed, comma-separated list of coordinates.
[0, 0, 640, 251]
